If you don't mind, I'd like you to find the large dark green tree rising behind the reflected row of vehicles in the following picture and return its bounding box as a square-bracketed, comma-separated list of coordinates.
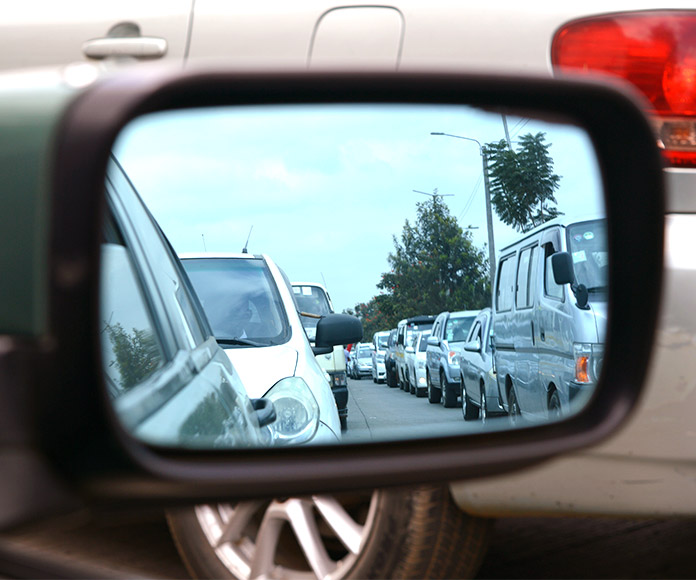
[354, 196, 491, 340]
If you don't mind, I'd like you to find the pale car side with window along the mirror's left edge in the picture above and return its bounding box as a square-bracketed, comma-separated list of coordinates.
[101, 163, 260, 447]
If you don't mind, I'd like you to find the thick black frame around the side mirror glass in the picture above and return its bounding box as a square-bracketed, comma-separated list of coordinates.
[39, 67, 664, 507]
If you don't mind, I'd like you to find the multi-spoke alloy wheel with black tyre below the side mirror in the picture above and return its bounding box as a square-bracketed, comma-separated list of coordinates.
[167, 486, 491, 580]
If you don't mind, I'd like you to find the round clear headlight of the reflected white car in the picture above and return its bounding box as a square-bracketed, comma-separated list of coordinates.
[264, 377, 319, 446]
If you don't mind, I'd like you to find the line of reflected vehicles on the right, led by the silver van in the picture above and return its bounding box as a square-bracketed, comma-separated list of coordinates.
[362, 217, 607, 421]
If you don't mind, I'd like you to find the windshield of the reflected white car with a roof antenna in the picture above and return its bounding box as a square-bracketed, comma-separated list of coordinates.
[182, 258, 290, 347]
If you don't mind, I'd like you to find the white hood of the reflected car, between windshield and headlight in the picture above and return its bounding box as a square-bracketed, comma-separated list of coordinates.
[225, 345, 298, 399]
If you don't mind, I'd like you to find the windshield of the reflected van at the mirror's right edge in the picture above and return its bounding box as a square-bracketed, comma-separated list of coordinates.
[566, 219, 609, 293]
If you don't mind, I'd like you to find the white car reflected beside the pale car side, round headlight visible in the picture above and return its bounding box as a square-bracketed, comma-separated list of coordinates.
[180, 253, 341, 443]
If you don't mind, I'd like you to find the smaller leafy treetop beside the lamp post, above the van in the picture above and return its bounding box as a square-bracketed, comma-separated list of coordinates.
[484, 133, 563, 232]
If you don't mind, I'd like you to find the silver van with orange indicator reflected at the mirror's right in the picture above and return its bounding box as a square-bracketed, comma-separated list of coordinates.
[493, 216, 608, 420]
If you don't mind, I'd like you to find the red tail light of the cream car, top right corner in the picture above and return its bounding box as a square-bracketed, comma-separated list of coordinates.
[551, 10, 696, 167]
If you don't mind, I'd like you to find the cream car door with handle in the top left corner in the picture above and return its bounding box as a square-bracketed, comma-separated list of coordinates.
[0, 0, 193, 70]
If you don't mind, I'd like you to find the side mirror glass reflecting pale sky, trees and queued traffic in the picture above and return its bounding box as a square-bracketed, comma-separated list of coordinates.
[102, 104, 608, 446]
